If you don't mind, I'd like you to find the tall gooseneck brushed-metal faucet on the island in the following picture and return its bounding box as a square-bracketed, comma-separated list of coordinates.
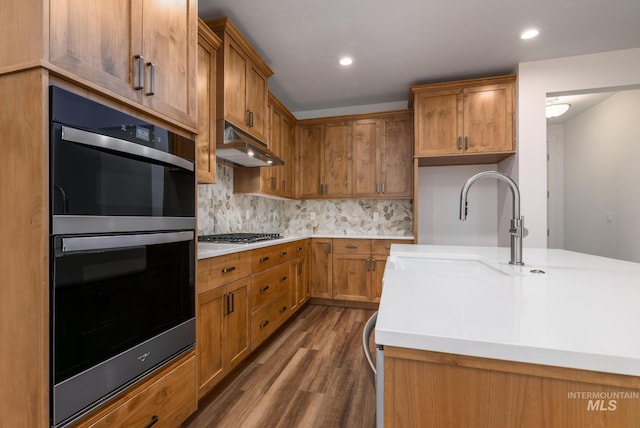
[460, 171, 524, 265]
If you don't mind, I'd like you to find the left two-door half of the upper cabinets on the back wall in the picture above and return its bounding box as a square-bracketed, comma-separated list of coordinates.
[297, 118, 353, 199]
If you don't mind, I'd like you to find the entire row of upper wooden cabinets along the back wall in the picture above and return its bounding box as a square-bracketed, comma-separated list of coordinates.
[297, 110, 413, 199]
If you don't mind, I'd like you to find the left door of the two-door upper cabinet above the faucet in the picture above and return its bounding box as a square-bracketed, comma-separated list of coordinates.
[414, 89, 463, 156]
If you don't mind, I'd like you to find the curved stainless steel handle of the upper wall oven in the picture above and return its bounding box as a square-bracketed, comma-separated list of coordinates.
[62, 126, 193, 171]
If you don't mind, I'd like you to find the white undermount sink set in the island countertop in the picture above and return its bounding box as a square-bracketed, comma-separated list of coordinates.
[388, 255, 511, 278]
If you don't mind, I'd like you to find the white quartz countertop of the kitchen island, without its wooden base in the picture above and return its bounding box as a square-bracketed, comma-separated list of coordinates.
[375, 245, 640, 376]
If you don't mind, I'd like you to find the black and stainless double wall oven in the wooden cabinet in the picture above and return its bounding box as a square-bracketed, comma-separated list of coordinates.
[50, 87, 196, 426]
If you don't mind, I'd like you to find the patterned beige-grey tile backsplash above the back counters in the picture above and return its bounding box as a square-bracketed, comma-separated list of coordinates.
[198, 164, 413, 236]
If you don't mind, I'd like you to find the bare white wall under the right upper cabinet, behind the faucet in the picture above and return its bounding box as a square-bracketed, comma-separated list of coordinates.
[417, 164, 507, 247]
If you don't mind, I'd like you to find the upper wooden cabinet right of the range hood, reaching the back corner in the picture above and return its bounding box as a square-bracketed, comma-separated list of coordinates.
[233, 93, 296, 198]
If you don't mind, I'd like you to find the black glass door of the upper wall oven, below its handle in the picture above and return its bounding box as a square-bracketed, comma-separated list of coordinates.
[51, 125, 195, 217]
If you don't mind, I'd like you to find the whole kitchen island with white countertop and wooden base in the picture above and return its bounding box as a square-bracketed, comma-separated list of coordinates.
[375, 245, 640, 427]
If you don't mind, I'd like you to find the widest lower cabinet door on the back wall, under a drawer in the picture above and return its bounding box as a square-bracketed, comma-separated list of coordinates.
[333, 253, 372, 302]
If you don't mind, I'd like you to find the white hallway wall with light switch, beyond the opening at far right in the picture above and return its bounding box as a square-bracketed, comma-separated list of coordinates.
[564, 90, 640, 262]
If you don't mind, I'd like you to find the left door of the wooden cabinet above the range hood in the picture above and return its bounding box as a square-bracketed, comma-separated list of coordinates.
[224, 37, 250, 130]
